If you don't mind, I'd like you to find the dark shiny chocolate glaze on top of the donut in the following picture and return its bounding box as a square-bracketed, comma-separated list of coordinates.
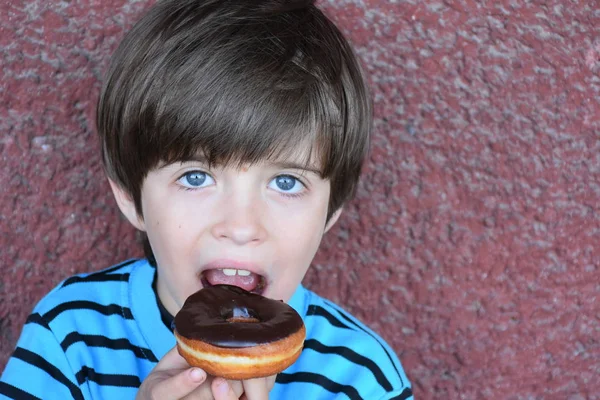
[174, 285, 304, 348]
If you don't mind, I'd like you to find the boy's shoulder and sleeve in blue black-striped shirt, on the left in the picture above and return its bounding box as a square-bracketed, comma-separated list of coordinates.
[0, 260, 150, 398]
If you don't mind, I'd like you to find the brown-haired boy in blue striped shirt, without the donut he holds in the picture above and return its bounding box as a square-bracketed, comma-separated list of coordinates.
[0, 0, 412, 400]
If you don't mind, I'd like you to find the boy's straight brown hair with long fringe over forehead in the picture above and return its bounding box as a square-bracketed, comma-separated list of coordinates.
[97, 0, 372, 222]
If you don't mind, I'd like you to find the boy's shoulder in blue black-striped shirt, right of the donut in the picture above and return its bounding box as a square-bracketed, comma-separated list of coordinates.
[282, 290, 412, 399]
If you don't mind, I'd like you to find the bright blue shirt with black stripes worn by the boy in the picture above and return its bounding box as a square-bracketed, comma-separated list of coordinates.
[0, 259, 412, 400]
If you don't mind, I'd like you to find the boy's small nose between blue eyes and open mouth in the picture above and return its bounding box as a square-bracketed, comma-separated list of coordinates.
[212, 193, 267, 245]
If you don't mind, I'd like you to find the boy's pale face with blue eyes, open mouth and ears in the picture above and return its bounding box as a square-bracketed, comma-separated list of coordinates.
[111, 148, 340, 314]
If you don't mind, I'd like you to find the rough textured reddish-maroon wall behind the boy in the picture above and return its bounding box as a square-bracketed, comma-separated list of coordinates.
[0, 0, 600, 400]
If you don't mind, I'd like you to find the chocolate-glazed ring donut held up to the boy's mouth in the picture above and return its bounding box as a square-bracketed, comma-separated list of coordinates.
[174, 285, 306, 380]
